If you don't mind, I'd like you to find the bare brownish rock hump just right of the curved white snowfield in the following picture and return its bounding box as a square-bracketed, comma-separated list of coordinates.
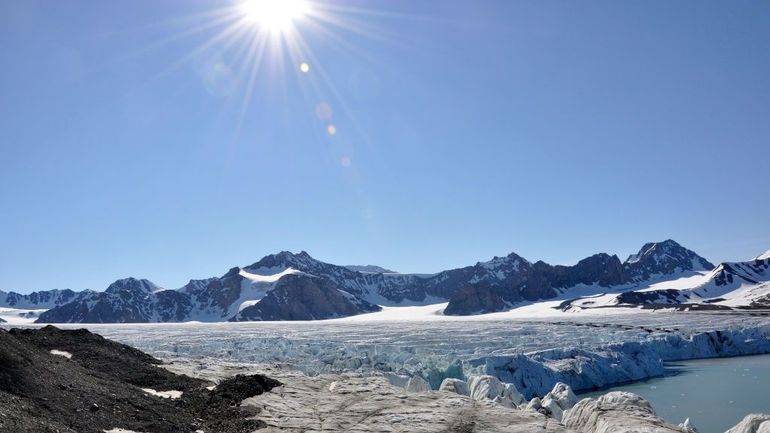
[233, 275, 381, 321]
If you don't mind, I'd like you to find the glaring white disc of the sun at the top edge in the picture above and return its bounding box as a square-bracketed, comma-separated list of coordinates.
[241, 0, 309, 33]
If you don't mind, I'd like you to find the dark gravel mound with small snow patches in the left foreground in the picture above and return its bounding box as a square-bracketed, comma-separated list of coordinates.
[0, 327, 280, 433]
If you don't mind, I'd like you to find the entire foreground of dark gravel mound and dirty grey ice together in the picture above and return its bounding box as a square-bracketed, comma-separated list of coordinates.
[0, 326, 770, 433]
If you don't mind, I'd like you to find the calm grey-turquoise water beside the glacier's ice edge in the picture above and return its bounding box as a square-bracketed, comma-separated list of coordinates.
[579, 355, 770, 433]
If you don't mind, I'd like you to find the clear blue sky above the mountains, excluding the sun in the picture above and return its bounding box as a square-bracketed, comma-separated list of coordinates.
[0, 0, 770, 292]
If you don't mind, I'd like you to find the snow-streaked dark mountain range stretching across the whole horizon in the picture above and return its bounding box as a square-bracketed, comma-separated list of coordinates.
[0, 240, 770, 323]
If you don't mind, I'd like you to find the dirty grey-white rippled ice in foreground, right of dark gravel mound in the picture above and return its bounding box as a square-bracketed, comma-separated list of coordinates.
[167, 360, 770, 433]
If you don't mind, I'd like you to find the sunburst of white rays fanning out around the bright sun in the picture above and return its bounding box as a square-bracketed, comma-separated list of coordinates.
[116, 0, 422, 159]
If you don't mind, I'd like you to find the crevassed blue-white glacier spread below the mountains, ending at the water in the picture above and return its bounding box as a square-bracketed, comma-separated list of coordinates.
[57, 312, 770, 399]
